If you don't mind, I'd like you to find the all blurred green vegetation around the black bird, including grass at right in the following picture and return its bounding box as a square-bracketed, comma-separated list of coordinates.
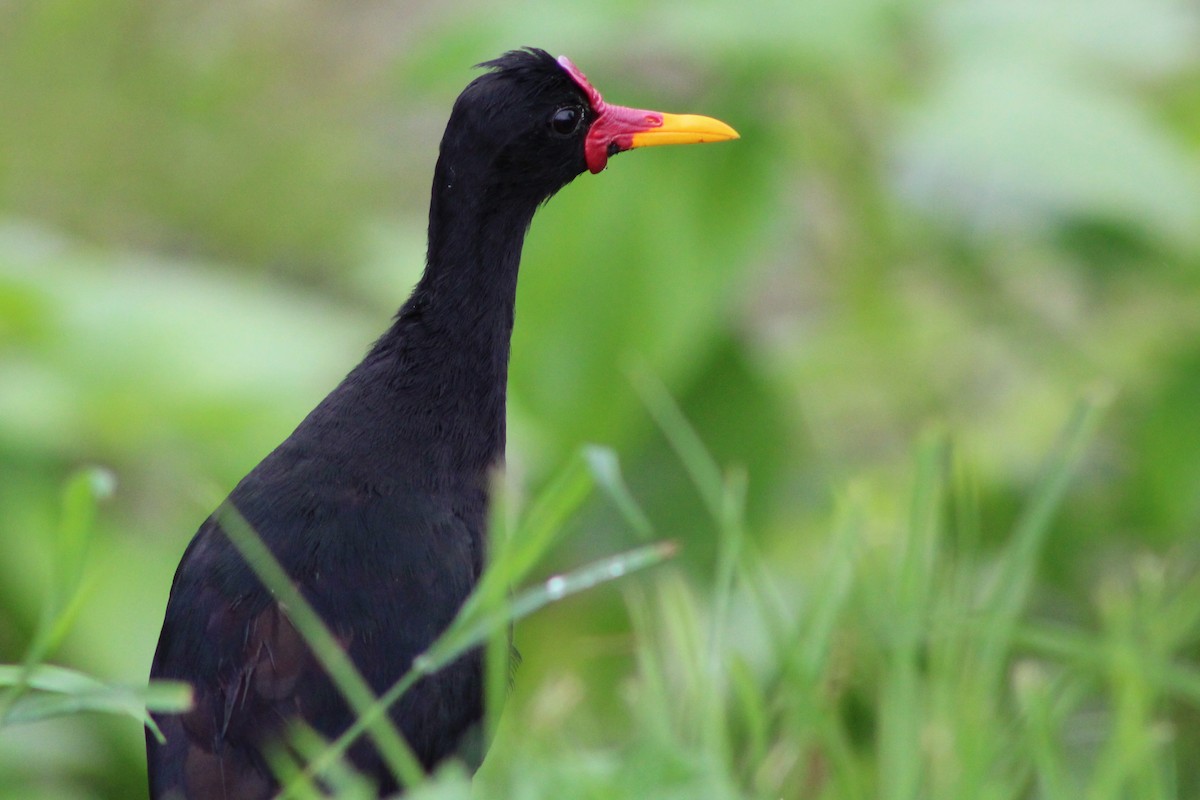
[0, 0, 1200, 798]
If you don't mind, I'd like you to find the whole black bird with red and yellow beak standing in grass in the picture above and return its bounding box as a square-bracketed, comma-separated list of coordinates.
[146, 48, 737, 800]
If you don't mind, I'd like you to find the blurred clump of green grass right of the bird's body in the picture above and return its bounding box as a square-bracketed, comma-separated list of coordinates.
[465, 391, 1200, 799]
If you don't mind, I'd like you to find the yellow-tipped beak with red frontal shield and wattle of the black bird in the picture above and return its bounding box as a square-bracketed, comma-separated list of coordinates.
[558, 56, 738, 173]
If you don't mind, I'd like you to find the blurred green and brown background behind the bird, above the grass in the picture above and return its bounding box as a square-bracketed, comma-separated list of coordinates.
[0, 0, 1200, 798]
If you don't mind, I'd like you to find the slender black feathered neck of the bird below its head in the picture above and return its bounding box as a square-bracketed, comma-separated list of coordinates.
[368, 161, 536, 489]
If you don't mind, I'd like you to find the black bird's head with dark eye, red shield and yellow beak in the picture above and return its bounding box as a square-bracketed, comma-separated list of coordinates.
[443, 48, 738, 205]
